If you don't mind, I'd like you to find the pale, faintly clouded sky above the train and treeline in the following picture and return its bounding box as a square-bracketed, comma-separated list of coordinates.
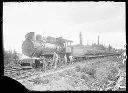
[3, 2, 126, 53]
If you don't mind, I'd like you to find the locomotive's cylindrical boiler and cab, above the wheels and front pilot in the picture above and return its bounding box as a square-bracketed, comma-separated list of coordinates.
[22, 32, 72, 58]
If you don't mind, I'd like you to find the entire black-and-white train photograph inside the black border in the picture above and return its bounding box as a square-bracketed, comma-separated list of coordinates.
[3, 1, 127, 91]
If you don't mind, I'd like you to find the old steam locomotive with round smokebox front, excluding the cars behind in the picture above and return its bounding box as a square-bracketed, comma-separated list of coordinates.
[21, 32, 73, 67]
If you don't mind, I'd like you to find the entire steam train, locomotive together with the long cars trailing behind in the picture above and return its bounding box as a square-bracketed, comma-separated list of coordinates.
[22, 32, 120, 69]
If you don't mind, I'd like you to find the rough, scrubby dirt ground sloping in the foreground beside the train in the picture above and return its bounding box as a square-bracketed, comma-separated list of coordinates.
[5, 57, 126, 91]
